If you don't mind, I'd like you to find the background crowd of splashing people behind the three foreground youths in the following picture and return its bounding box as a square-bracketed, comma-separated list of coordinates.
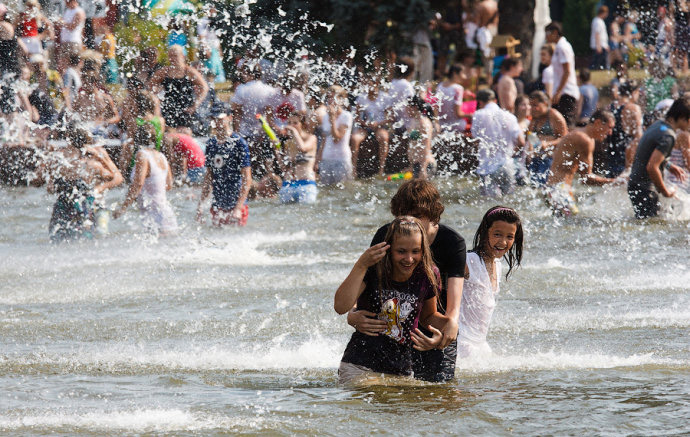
[0, 0, 690, 239]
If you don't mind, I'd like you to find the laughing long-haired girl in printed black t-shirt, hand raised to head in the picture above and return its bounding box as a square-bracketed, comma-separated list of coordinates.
[334, 216, 448, 383]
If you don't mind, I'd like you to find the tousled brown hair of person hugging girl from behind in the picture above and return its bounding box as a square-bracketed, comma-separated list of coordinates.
[391, 179, 445, 223]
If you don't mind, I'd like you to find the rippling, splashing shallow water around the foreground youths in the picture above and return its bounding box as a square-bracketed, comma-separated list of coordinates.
[0, 179, 690, 435]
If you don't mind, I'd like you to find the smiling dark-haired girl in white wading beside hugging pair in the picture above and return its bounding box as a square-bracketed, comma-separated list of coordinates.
[458, 206, 523, 359]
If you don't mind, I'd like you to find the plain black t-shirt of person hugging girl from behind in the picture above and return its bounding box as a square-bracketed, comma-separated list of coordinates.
[371, 223, 467, 314]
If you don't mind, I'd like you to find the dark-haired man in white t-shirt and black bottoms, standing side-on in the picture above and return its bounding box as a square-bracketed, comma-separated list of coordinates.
[545, 23, 580, 126]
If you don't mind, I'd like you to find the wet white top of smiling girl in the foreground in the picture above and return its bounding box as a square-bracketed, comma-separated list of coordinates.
[458, 252, 501, 358]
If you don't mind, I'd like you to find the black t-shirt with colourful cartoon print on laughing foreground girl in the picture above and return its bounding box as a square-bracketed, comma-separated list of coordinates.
[343, 269, 436, 375]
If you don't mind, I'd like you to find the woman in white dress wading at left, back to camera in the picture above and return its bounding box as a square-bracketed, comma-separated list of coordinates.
[113, 123, 177, 237]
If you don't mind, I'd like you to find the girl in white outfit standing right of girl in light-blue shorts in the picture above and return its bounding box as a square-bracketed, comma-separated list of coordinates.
[316, 85, 352, 185]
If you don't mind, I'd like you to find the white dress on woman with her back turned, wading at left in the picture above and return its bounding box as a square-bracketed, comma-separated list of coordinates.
[132, 149, 177, 234]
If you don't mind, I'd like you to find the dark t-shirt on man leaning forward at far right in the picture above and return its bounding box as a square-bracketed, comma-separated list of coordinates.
[628, 120, 676, 190]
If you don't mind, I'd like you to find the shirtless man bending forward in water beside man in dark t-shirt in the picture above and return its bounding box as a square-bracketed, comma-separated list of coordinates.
[546, 110, 617, 216]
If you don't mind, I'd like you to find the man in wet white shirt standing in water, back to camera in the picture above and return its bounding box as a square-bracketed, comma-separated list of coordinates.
[472, 89, 525, 197]
